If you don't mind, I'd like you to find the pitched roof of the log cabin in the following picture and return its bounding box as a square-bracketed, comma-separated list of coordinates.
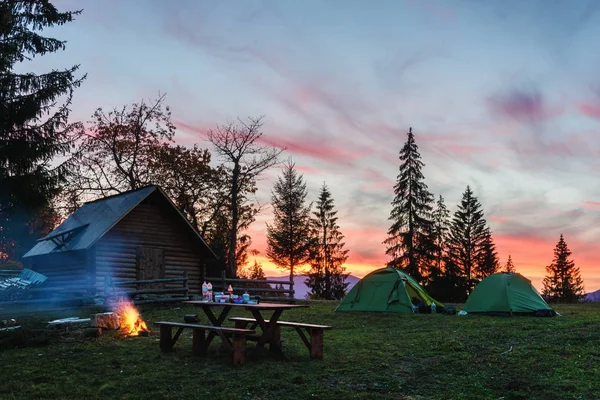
[23, 185, 217, 258]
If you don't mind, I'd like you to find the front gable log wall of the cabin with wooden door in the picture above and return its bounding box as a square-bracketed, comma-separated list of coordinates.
[95, 195, 204, 293]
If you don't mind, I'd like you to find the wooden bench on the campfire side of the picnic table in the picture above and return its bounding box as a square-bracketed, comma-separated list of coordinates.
[154, 321, 256, 365]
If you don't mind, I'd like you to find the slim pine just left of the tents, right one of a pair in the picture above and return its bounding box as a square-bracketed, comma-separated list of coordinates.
[305, 184, 349, 300]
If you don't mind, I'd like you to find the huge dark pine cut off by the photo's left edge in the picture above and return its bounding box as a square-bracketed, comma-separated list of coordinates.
[0, 0, 85, 258]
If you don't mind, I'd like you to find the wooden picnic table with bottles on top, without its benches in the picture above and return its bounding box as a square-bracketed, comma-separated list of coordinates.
[183, 300, 308, 354]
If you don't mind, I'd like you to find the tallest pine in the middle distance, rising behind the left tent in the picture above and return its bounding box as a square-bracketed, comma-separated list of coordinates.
[384, 128, 436, 281]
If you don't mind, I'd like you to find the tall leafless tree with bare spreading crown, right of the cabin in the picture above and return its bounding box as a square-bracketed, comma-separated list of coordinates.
[208, 117, 283, 276]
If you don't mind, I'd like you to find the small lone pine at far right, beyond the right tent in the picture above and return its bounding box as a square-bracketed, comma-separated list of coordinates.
[542, 234, 583, 303]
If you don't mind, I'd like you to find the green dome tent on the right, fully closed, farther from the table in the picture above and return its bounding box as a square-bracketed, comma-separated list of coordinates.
[463, 272, 552, 314]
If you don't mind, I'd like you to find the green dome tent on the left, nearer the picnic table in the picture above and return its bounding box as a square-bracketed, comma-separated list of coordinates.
[336, 268, 444, 313]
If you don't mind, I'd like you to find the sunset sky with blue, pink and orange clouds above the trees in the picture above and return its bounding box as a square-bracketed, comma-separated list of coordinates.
[36, 0, 600, 291]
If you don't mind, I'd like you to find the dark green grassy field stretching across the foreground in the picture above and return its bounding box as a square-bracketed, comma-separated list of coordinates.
[0, 302, 600, 400]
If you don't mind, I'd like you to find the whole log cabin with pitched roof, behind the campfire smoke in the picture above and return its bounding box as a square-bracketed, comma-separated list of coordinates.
[23, 186, 216, 295]
